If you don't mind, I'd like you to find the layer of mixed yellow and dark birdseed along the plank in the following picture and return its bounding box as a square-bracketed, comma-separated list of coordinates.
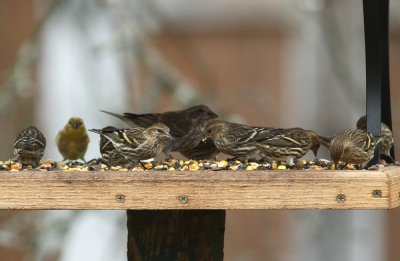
[0, 158, 384, 171]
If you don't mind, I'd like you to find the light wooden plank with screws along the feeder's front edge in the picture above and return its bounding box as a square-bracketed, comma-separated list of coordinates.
[0, 167, 400, 209]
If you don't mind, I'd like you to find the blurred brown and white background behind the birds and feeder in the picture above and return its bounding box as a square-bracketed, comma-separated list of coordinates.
[0, 0, 400, 261]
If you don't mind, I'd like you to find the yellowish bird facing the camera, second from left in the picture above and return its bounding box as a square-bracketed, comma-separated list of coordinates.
[55, 117, 90, 161]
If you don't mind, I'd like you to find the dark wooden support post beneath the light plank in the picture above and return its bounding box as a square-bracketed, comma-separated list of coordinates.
[127, 210, 225, 261]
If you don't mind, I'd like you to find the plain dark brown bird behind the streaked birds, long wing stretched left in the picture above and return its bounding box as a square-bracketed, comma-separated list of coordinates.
[102, 105, 217, 157]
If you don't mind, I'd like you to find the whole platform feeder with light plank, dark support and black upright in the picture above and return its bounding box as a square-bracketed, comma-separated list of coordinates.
[0, 0, 394, 260]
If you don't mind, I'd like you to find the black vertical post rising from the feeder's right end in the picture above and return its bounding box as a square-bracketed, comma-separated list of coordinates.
[363, 0, 391, 164]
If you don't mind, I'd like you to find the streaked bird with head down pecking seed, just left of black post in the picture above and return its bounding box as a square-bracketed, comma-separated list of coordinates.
[329, 130, 381, 168]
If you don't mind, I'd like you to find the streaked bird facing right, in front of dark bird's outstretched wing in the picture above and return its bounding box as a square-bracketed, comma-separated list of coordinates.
[89, 123, 171, 163]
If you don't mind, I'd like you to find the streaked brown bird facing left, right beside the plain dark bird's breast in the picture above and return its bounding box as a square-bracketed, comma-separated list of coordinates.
[204, 120, 283, 159]
